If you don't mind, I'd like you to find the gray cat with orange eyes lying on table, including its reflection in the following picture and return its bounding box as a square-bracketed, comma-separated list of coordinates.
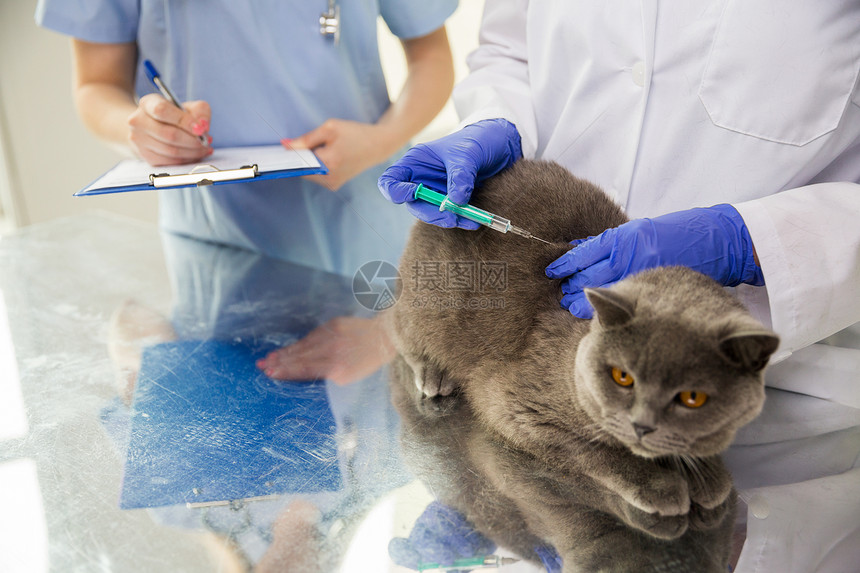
[388, 160, 778, 573]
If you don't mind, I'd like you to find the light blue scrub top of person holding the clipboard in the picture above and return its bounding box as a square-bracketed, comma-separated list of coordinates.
[36, 0, 457, 276]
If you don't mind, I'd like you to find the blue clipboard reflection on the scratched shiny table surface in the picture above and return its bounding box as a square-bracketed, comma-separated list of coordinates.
[120, 340, 343, 509]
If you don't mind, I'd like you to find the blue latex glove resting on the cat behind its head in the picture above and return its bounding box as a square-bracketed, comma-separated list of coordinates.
[546, 204, 764, 318]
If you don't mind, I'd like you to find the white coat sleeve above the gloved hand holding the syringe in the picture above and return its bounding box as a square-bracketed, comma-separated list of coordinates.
[453, 0, 537, 158]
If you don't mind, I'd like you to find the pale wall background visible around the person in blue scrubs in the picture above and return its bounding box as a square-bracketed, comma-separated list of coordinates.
[0, 0, 484, 234]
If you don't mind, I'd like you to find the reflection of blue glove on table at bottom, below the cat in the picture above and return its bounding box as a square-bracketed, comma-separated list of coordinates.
[388, 501, 496, 570]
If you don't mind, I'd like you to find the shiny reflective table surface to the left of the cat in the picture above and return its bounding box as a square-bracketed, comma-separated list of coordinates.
[0, 215, 454, 572]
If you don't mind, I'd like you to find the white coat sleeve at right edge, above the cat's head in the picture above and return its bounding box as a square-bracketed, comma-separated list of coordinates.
[735, 182, 860, 360]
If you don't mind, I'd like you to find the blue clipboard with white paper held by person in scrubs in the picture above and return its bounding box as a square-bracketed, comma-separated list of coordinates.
[74, 145, 328, 197]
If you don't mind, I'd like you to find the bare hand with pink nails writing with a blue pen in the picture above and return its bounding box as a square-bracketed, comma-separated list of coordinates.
[128, 60, 212, 165]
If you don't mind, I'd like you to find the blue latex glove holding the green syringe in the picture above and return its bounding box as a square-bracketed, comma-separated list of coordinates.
[379, 119, 523, 230]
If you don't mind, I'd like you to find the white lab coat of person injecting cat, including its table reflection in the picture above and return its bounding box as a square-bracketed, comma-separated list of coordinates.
[454, 0, 860, 573]
